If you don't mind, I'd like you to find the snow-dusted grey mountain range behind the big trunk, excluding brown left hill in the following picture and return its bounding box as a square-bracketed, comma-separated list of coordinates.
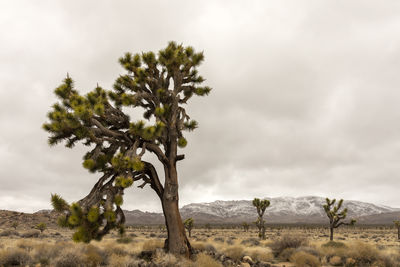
[125, 196, 400, 224]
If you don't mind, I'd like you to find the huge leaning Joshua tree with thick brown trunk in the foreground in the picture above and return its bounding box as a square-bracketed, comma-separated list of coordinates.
[43, 42, 211, 257]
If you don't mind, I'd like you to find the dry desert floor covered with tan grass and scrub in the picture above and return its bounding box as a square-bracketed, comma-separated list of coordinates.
[0, 226, 400, 267]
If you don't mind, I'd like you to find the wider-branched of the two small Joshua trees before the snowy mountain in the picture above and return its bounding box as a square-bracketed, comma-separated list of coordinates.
[323, 198, 356, 241]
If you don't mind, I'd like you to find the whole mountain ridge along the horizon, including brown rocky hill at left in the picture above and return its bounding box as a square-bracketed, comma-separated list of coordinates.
[0, 196, 400, 226]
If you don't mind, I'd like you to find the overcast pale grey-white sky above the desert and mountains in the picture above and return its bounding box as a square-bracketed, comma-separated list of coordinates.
[0, 0, 400, 212]
